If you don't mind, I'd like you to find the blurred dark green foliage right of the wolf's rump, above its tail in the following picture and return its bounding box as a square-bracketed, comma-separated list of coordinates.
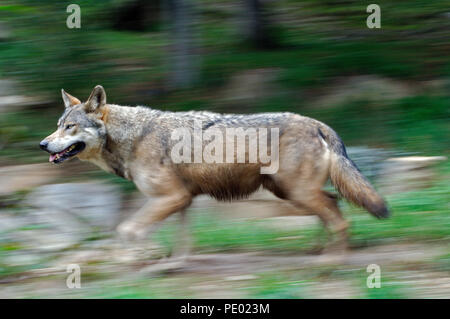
[304, 95, 450, 155]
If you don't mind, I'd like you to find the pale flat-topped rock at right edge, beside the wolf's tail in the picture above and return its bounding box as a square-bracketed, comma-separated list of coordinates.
[379, 156, 447, 194]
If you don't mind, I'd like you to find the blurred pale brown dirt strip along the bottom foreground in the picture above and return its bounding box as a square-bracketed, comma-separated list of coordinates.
[0, 244, 450, 298]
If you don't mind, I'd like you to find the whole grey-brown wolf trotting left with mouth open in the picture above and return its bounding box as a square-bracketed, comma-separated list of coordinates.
[40, 85, 390, 258]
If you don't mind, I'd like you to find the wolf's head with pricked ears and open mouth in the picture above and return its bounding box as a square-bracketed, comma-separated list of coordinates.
[40, 85, 106, 163]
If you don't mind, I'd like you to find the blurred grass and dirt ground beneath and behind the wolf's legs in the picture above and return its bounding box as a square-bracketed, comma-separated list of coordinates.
[0, 169, 450, 298]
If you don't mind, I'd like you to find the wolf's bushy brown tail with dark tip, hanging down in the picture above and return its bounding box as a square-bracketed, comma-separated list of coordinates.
[319, 126, 390, 218]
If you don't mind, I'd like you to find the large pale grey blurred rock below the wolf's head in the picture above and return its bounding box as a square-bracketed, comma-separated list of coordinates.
[7, 182, 121, 252]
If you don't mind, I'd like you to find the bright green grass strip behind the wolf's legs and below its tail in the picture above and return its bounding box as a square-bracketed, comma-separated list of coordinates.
[149, 163, 450, 252]
